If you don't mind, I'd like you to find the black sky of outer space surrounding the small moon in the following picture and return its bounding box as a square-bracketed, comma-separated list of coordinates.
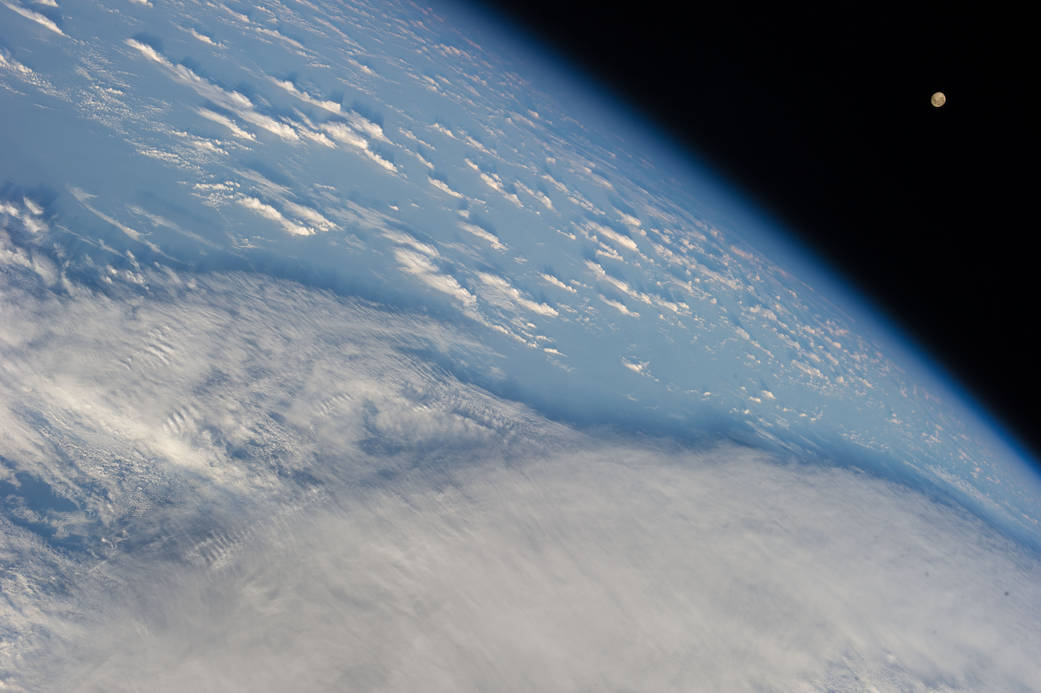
[474, 0, 1041, 462]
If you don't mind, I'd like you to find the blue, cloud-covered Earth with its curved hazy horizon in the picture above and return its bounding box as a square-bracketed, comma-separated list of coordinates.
[0, 0, 1041, 691]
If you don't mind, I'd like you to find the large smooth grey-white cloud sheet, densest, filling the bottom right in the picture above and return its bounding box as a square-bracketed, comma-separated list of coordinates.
[24, 447, 1041, 691]
